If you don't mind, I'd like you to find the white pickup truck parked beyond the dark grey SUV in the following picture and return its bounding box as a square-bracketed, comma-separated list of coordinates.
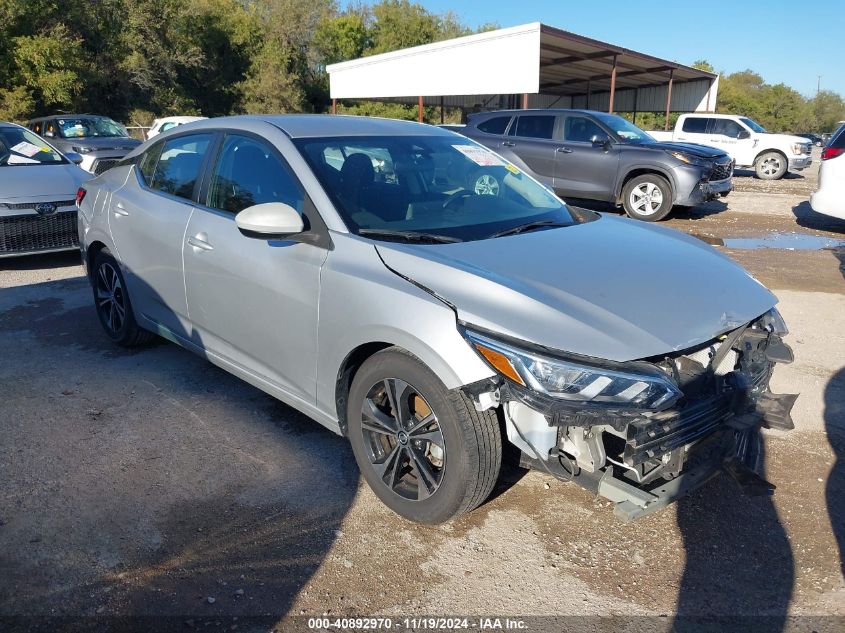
[649, 113, 813, 180]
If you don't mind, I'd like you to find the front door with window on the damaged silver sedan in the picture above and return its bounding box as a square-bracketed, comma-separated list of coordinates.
[183, 134, 327, 403]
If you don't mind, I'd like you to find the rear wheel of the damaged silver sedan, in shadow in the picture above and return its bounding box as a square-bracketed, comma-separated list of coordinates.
[91, 248, 155, 347]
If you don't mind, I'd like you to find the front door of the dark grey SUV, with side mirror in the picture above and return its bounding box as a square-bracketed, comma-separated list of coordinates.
[554, 113, 621, 200]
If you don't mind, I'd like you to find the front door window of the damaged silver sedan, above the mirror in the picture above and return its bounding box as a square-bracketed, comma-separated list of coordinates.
[207, 134, 304, 213]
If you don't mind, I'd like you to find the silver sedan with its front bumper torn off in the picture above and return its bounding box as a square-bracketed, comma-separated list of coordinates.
[79, 115, 795, 523]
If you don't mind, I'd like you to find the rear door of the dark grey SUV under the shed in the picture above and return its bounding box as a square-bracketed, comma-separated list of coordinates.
[500, 113, 560, 187]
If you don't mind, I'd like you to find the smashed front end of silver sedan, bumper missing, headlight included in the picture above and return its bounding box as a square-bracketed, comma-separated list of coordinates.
[465, 309, 797, 520]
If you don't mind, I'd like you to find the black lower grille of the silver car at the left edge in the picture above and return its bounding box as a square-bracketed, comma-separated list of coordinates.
[0, 211, 79, 253]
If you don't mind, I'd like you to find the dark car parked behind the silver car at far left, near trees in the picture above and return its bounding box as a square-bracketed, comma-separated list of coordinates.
[26, 114, 141, 174]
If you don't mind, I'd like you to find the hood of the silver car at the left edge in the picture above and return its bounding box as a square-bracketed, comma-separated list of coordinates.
[0, 164, 89, 200]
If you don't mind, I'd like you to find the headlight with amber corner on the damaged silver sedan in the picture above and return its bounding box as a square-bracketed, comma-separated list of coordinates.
[465, 330, 681, 410]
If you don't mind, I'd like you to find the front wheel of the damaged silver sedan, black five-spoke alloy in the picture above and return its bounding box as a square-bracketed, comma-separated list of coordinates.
[347, 347, 502, 525]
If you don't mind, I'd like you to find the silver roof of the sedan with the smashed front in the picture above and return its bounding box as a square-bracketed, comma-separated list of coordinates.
[178, 114, 454, 138]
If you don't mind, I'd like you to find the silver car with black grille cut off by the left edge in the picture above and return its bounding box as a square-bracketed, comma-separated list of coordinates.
[0, 121, 91, 257]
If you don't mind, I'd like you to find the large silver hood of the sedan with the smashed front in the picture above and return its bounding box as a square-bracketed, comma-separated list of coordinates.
[377, 216, 777, 361]
